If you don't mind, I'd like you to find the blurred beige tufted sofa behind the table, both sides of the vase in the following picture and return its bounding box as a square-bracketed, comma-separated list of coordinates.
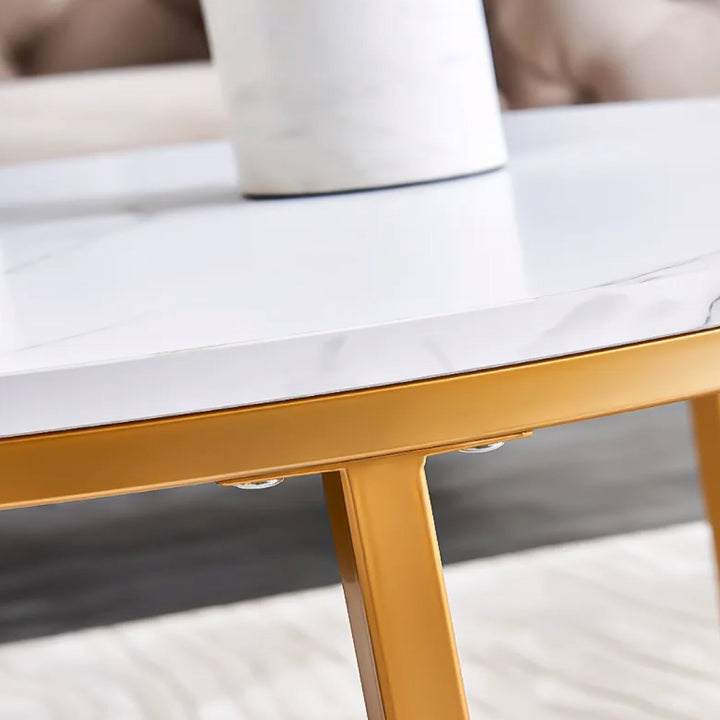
[0, 0, 720, 162]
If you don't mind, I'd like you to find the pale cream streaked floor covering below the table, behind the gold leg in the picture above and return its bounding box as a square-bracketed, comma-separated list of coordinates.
[0, 523, 720, 720]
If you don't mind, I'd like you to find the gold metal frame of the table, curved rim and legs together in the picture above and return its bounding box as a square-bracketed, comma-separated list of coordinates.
[0, 330, 720, 720]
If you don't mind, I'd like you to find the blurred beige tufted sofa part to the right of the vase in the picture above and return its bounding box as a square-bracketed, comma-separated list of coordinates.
[487, 0, 720, 107]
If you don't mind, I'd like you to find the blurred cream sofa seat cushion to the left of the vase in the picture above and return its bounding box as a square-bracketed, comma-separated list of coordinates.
[0, 63, 226, 163]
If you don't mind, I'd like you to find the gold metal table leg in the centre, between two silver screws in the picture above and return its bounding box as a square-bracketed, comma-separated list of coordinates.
[323, 455, 468, 720]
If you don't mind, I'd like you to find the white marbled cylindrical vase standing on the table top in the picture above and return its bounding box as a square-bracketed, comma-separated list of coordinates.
[203, 0, 506, 196]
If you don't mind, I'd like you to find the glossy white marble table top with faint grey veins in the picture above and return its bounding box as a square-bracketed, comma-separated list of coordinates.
[0, 100, 720, 436]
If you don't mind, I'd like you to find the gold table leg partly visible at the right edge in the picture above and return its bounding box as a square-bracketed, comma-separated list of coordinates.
[692, 394, 720, 561]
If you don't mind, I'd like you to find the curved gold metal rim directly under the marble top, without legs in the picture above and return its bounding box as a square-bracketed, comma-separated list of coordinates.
[0, 330, 720, 508]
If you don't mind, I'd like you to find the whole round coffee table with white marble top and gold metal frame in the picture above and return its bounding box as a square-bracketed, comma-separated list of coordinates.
[0, 100, 720, 720]
